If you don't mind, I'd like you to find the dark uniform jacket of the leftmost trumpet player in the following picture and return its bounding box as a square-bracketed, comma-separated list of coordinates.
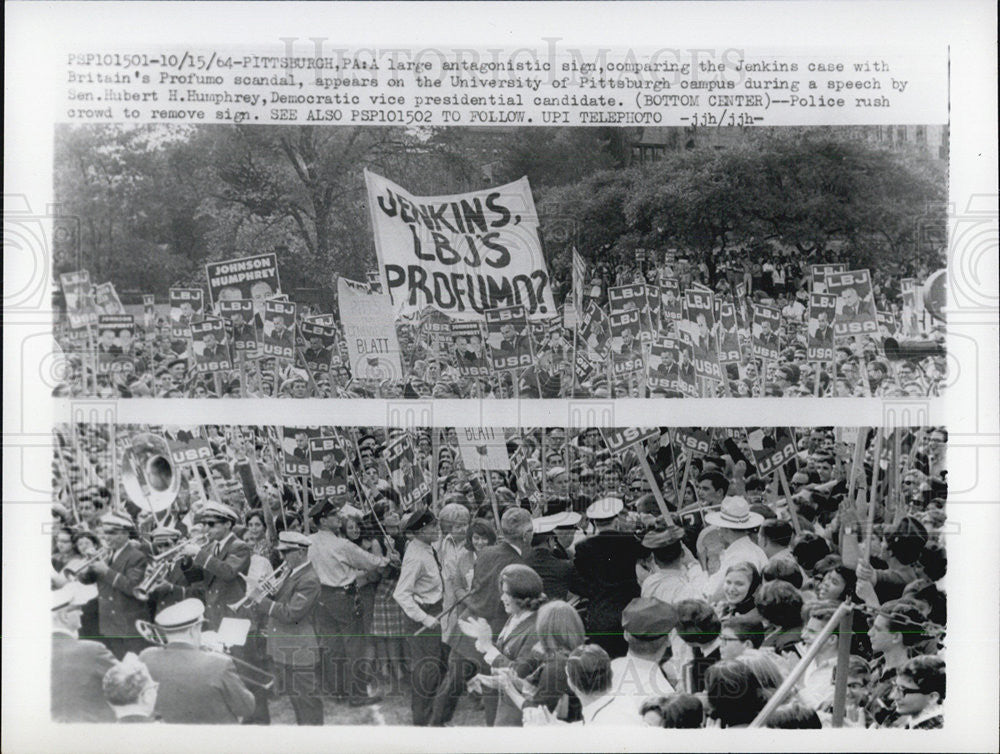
[80, 541, 149, 638]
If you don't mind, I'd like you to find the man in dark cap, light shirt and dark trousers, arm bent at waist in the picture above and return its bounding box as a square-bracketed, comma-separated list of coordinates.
[392, 510, 446, 725]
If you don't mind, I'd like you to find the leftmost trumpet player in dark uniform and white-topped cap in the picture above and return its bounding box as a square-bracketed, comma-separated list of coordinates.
[80, 513, 149, 659]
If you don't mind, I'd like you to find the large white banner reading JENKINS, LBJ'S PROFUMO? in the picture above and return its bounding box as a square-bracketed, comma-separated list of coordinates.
[365, 170, 556, 320]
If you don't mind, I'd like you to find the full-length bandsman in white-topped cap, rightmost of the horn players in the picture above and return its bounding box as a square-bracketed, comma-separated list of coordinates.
[249, 531, 323, 725]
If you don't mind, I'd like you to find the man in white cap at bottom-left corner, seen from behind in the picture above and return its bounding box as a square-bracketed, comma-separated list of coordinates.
[50, 581, 115, 723]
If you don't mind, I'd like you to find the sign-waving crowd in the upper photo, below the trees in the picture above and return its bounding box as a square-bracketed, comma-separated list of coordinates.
[55, 249, 947, 398]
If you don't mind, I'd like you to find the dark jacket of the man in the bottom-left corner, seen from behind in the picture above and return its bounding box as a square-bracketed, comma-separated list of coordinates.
[51, 626, 116, 723]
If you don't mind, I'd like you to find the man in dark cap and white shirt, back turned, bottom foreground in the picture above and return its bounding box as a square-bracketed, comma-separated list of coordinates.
[611, 597, 677, 715]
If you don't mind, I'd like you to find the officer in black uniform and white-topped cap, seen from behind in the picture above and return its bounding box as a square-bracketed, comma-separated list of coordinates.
[572, 497, 643, 658]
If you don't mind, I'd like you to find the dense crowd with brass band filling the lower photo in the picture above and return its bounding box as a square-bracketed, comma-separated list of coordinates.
[51, 426, 948, 729]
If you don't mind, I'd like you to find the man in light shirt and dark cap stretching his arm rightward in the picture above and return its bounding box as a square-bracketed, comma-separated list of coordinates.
[309, 501, 399, 707]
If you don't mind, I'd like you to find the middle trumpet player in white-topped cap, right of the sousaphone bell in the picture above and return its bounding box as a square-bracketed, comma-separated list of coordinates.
[183, 501, 253, 631]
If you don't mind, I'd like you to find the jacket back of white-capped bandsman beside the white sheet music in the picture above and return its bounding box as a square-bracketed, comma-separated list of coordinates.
[139, 644, 254, 725]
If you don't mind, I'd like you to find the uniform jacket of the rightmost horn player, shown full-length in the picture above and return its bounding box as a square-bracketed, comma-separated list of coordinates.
[258, 562, 320, 667]
